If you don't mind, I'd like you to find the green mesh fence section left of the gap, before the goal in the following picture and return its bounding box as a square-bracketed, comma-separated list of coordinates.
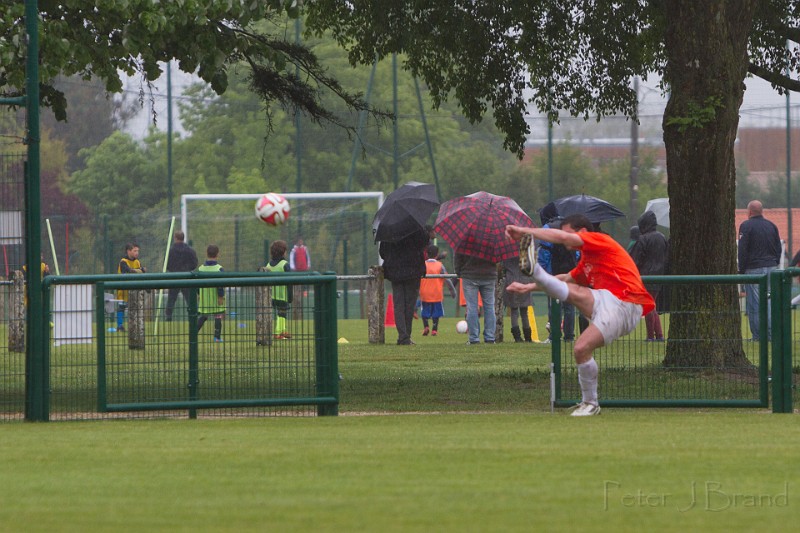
[16, 272, 339, 420]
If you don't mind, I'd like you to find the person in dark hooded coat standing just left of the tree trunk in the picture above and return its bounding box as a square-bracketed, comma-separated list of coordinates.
[630, 211, 669, 341]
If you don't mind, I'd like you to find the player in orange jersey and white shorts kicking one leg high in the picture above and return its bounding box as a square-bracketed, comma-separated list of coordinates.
[506, 215, 656, 416]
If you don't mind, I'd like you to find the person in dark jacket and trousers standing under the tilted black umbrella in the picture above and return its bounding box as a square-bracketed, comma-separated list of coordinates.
[379, 228, 429, 345]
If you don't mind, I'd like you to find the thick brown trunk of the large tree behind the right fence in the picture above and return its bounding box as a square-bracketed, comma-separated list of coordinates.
[663, 0, 757, 368]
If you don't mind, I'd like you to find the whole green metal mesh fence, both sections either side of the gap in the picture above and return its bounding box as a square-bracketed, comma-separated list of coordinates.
[7, 269, 800, 420]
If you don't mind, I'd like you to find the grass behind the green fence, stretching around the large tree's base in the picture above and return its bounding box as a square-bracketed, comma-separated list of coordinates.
[0, 316, 766, 419]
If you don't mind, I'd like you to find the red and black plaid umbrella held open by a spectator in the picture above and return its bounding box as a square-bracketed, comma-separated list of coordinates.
[434, 191, 533, 263]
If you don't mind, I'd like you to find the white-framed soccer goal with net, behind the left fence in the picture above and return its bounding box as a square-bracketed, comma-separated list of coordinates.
[181, 192, 383, 274]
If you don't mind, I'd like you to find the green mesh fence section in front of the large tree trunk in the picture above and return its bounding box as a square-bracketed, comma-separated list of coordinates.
[551, 271, 772, 407]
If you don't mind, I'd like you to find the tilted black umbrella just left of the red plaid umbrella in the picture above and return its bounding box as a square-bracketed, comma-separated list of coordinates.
[372, 181, 439, 242]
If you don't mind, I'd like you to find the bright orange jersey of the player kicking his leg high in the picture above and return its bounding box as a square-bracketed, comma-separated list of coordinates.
[569, 232, 656, 316]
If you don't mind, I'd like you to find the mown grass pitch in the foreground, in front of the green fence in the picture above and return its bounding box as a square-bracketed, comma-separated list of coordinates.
[0, 409, 800, 531]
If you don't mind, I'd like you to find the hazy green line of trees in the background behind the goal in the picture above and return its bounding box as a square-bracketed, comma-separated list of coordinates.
[21, 28, 666, 270]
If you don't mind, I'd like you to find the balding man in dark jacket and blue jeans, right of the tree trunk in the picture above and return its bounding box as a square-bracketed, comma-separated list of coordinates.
[739, 200, 781, 341]
